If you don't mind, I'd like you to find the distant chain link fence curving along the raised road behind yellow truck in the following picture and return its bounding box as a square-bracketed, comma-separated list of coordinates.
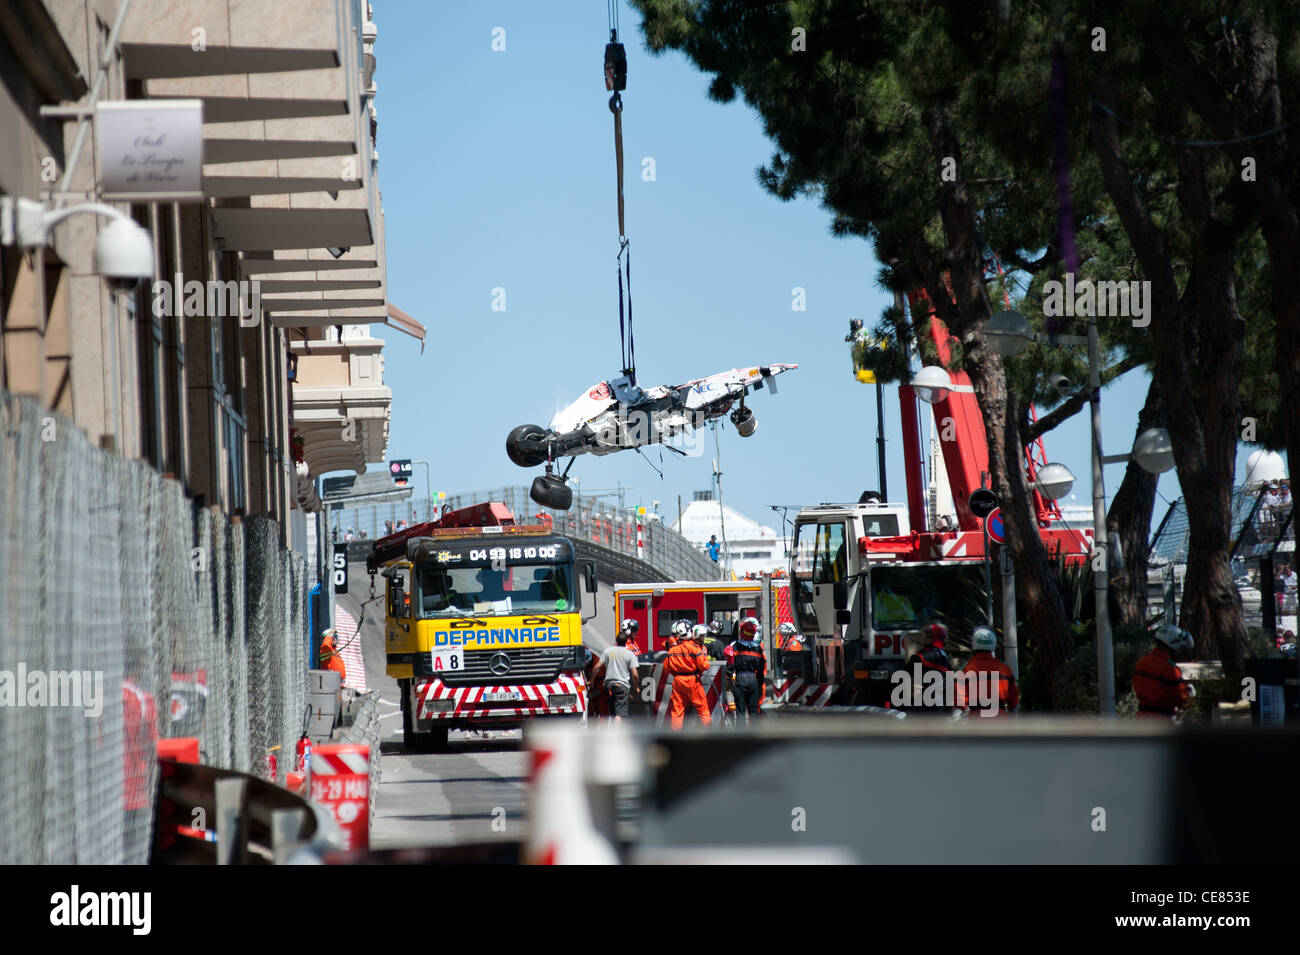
[330, 485, 722, 581]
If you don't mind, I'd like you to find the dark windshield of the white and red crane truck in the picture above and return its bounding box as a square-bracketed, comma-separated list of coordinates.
[871, 561, 984, 634]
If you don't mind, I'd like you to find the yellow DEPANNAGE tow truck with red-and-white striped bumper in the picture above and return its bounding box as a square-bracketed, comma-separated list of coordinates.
[367, 503, 597, 751]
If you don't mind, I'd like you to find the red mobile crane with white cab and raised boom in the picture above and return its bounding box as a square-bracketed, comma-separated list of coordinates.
[776, 291, 1092, 706]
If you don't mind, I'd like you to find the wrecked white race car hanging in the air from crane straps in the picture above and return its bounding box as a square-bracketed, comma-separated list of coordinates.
[506, 365, 798, 511]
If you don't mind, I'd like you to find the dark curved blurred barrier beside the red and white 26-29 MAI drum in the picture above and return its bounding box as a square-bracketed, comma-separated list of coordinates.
[150, 759, 342, 865]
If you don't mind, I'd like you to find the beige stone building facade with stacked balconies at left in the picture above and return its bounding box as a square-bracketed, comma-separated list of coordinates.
[0, 0, 424, 548]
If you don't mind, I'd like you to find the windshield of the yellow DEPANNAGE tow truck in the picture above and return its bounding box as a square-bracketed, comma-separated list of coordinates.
[417, 563, 579, 617]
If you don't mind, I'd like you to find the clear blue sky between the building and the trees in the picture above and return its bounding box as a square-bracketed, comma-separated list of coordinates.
[372, 0, 1279, 537]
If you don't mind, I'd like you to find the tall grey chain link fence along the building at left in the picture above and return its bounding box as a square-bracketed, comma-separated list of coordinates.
[0, 392, 308, 864]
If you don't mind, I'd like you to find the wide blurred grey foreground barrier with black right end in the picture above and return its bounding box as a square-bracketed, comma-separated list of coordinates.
[632, 716, 1300, 865]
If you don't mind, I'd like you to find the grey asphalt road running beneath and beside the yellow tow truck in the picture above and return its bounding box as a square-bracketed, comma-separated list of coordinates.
[338, 563, 618, 850]
